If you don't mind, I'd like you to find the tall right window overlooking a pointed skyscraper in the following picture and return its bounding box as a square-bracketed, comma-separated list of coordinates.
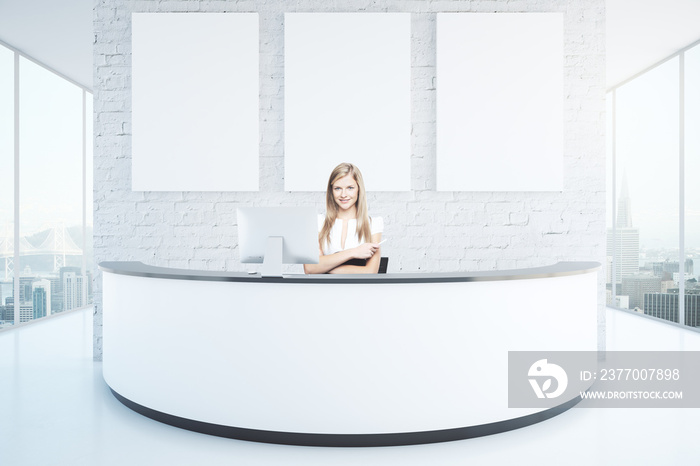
[607, 41, 700, 327]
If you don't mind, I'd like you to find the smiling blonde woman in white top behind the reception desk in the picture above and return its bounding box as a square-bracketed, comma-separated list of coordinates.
[304, 163, 384, 273]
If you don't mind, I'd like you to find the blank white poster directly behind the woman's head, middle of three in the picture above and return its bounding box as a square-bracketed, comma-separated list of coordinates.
[284, 13, 411, 191]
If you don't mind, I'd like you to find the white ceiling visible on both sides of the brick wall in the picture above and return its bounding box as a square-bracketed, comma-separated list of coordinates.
[0, 0, 700, 93]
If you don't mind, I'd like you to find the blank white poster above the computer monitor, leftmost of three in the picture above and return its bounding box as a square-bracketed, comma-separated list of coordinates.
[132, 13, 259, 191]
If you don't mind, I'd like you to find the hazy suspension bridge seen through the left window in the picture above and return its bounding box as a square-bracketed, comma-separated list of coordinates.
[0, 224, 83, 280]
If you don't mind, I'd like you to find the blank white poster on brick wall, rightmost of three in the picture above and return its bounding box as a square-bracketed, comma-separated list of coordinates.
[437, 13, 564, 191]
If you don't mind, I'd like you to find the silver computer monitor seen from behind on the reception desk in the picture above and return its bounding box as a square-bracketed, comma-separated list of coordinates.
[238, 207, 318, 277]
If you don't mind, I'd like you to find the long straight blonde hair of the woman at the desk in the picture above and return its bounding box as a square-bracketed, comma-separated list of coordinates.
[318, 163, 372, 249]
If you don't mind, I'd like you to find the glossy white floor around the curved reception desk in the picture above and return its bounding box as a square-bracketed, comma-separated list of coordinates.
[0, 310, 700, 466]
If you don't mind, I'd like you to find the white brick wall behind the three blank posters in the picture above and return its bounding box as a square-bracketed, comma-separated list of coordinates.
[94, 0, 605, 359]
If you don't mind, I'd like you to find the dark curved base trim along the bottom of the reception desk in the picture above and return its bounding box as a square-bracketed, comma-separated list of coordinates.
[110, 387, 581, 447]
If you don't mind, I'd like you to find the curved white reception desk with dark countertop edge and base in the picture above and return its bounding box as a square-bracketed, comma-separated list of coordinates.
[100, 262, 599, 446]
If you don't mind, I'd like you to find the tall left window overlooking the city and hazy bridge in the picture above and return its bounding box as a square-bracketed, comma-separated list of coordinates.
[0, 42, 92, 326]
